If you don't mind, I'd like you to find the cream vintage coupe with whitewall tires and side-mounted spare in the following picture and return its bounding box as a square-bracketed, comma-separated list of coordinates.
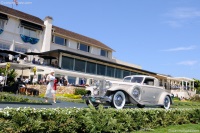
[82, 75, 172, 109]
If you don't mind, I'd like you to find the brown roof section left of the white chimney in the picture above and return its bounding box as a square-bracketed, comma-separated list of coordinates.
[0, 5, 44, 25]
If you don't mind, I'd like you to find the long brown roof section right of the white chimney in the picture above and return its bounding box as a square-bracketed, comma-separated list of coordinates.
[53, 26, 113, 51]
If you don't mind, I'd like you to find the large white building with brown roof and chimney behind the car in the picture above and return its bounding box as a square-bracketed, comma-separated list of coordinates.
[0, 5, 194, 96]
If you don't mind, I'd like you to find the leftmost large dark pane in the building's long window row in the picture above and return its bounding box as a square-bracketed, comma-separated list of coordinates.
[61, 56, 74, 70]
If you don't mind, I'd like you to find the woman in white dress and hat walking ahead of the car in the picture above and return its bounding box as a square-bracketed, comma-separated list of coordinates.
[45, 69, 56, 103]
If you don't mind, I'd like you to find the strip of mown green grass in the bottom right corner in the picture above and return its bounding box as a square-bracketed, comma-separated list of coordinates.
[137, 124, 200, 133]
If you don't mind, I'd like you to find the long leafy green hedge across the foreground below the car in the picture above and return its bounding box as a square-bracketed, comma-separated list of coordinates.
[0, 106, 200, 133]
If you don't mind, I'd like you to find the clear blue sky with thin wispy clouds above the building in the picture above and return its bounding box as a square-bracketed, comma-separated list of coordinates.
[1, 0, 200, 79]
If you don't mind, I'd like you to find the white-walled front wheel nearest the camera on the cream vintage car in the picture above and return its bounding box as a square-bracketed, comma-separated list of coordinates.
[111, 91, 126, 109]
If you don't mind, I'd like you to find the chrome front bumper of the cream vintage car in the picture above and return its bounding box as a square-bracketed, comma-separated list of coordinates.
[82, 96, 112, 103]
